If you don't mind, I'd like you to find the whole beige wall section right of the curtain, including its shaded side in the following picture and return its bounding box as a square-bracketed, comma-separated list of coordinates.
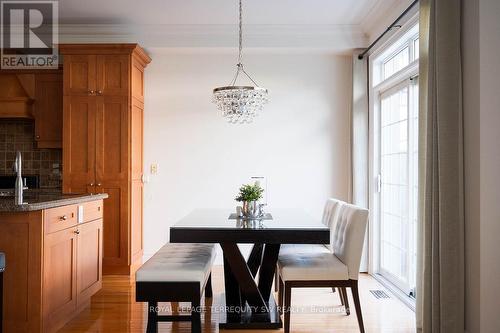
[462, 0, 500, 333]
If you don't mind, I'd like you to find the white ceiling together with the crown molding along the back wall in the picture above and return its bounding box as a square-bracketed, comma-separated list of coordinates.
[59, 0, 411, 52]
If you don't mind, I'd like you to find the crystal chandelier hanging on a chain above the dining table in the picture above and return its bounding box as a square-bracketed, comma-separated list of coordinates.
[213, 0, 268, 124]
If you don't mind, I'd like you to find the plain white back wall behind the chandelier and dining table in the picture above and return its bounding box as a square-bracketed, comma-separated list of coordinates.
[144, 49, 351, 256]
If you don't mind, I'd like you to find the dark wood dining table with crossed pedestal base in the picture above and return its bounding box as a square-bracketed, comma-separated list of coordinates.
[170, 209, 330, 329]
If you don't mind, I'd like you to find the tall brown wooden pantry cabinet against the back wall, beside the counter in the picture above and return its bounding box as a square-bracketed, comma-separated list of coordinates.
[59, 44, 151, 274]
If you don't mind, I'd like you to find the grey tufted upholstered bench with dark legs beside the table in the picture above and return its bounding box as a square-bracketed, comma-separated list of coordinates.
[135, 243, 216, 333]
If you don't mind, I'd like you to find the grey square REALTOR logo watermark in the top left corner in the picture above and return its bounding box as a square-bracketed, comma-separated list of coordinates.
[0, 0, 59, 69]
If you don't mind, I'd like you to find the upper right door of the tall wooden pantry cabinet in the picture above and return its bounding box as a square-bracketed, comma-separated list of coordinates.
[97, 54, 130, 96]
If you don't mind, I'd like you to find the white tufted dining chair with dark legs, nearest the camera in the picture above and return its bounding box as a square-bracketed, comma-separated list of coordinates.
[278, 204, 368, 333]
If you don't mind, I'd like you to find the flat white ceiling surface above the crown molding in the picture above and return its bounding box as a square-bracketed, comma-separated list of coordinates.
[59, 0, 378, 24]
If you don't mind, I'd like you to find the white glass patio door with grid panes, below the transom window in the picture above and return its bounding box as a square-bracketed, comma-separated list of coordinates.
[378, 79, 418, 295]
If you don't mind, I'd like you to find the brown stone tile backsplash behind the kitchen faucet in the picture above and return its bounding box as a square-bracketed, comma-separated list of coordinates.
[0, 119, 62, 189]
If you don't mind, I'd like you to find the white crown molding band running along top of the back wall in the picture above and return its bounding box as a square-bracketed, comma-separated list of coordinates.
[59, 24, 367, 53]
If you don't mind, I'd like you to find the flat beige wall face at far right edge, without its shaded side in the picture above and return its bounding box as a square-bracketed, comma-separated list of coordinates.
[479, 0, 500, 333]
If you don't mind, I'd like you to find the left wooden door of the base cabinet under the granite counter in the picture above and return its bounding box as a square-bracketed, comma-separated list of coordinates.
[43, 228, 77, 330]
